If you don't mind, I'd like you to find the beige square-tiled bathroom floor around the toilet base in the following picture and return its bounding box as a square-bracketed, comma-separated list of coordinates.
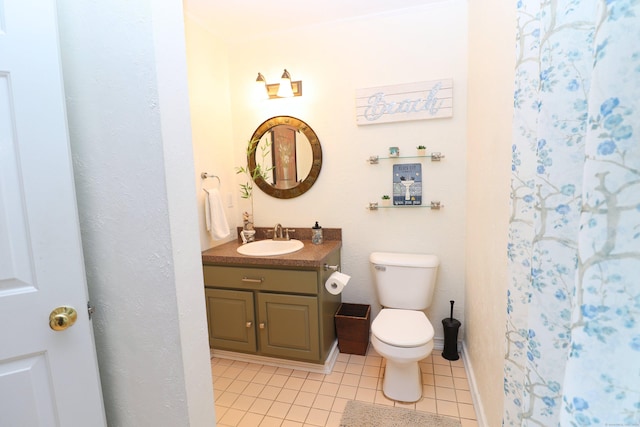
[211, 346, 478, 427]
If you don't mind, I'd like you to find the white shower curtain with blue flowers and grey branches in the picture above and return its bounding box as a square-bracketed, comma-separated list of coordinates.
[503, 0, 640, 426]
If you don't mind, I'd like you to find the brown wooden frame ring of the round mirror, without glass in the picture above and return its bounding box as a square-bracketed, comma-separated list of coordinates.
[247, 116, 322, 199]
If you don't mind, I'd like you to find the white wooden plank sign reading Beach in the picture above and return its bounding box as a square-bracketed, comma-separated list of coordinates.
[356, 79, 453, 125]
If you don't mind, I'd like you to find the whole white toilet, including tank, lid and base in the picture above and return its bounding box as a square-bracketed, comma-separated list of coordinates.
[369, 252, 440, 402]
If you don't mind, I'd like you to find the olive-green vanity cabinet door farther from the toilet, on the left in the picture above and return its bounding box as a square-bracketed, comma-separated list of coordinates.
[205, 288, 256, 353]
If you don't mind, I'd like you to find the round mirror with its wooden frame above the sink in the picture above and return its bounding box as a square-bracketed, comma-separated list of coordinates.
[247, 116, 322, 199]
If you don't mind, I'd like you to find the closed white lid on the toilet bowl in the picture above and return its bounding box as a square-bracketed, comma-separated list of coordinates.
[371, 308, 434, 347]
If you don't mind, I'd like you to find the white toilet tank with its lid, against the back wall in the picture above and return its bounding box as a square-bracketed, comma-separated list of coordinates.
[369, 252, 440, 310]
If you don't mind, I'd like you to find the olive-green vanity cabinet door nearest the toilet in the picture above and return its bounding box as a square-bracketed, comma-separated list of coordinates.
[257, 292, 320, 361]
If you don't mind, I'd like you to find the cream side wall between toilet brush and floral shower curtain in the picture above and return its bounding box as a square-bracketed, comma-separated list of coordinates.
[465, 0, 516, 426]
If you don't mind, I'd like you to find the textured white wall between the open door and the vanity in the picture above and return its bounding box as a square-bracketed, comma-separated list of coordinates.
[58, 0, 215, 426]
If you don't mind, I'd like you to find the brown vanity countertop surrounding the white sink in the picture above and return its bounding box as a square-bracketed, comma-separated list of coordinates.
[202, 229, 342, 268]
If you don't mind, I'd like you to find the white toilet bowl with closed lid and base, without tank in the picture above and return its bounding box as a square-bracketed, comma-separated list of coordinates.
[371, 309, 434, 402]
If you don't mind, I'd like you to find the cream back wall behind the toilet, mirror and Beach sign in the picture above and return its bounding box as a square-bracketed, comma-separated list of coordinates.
[226, 0, 467, 338]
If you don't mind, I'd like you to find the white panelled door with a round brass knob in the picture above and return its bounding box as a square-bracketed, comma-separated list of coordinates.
[0, 0, 106, 427]
